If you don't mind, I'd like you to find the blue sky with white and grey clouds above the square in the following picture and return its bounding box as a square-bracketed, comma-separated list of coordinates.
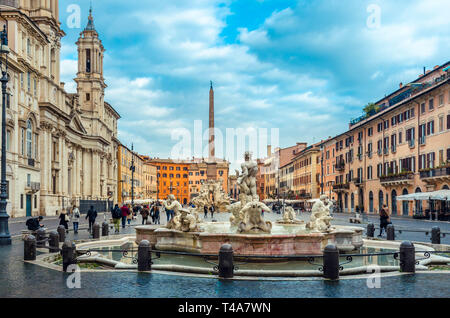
[60, 0, 450, 168]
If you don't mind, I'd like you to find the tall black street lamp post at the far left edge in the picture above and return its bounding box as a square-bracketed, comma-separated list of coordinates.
[0, 20, 11, 245]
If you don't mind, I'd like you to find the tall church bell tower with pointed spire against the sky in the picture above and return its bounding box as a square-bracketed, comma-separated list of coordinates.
[75, 8, 107, 125]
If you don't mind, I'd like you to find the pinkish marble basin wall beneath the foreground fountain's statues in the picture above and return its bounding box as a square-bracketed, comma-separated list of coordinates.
[136, 222, 363, 256]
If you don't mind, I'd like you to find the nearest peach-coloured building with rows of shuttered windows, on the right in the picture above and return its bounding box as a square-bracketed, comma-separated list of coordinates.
[324, 62, 450, 216]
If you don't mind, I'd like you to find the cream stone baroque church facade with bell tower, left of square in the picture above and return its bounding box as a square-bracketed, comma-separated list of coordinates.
[0, 0, 120, 217]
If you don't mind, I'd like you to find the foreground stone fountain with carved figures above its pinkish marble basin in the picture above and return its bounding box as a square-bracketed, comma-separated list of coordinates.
[136, 152, 363, 256]
